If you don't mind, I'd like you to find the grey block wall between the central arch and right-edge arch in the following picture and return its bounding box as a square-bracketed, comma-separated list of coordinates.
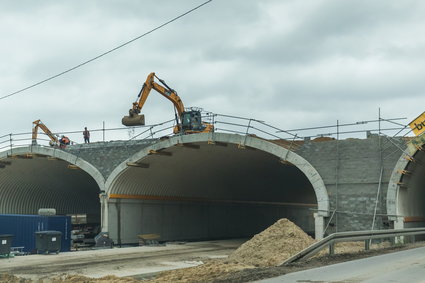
[296, 135, 405, 234]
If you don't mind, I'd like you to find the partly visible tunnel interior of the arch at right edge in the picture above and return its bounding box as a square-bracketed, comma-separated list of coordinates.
[398, 150, 425, 228]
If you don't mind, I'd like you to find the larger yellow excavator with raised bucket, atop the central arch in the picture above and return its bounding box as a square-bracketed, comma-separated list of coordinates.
[121, 72, 214, 134]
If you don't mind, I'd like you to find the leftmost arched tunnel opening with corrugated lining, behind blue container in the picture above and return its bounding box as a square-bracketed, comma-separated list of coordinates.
[0, 153, 101, 245]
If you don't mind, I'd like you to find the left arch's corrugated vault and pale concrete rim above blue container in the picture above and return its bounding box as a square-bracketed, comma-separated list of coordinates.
[0, 146, 104, 215]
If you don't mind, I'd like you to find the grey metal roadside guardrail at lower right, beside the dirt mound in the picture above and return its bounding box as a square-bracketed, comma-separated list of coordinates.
[280, 228, 425, 265]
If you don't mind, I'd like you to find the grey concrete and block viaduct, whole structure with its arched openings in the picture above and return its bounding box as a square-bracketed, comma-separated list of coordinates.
[0, 133, 425, 243]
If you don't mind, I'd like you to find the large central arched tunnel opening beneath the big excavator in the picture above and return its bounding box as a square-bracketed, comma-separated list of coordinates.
[108, 142, 318, 244]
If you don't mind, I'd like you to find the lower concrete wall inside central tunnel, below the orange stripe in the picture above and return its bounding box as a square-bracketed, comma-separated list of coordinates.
[109, 199, 314, 244]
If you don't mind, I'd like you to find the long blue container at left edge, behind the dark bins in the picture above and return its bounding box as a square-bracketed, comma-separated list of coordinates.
[0, 214, 71, 253]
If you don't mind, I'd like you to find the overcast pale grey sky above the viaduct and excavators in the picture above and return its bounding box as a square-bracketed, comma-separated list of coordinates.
[0, 0, 425, 144]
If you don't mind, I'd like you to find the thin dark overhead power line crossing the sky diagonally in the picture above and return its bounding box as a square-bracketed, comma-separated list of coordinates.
[0, 0, 212, 100]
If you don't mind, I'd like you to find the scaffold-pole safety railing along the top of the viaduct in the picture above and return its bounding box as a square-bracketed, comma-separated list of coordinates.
[0, 112, 410, 154]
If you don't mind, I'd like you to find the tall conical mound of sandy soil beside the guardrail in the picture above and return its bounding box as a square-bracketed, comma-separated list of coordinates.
[229, 218, 315, 267]
